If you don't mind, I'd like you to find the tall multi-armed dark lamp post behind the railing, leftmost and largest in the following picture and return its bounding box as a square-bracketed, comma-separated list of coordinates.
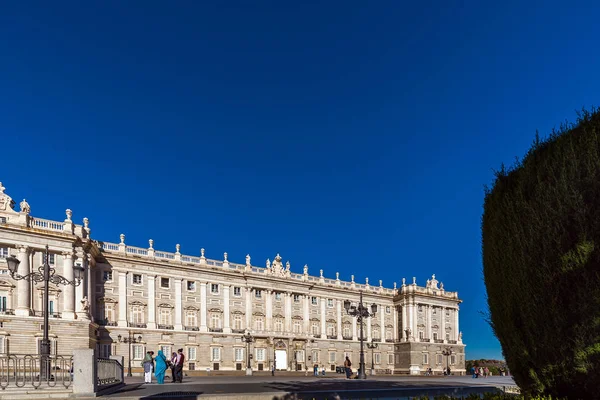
[6, 245, 83, 380]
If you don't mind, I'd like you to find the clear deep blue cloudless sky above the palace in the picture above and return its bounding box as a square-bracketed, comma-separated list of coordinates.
[0, 1, 600, 358]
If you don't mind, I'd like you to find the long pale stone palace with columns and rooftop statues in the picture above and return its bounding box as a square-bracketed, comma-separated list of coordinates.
[0, 183, 465, 374]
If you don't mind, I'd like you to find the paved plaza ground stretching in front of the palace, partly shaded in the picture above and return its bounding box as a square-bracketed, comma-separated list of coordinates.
[107, 375, 514, 400]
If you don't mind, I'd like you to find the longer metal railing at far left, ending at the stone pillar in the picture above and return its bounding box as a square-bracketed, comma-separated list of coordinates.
[0, 354, 73, 390]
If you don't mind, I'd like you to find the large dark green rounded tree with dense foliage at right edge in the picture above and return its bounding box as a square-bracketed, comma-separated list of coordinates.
[482, 109, 600, 399]
